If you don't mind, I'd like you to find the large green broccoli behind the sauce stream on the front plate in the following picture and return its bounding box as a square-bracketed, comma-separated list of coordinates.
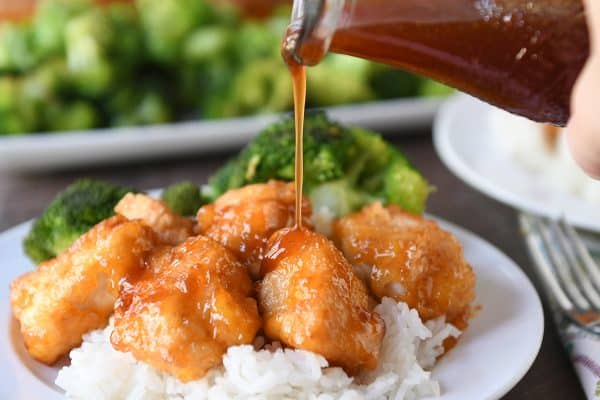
[202, 113, 430, 216]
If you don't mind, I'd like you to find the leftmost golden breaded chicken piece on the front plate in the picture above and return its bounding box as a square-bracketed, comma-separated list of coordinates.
[10, 216, 158, 364]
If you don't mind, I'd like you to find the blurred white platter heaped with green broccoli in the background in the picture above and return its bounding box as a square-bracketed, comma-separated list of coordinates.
[0, 0, 452, 171]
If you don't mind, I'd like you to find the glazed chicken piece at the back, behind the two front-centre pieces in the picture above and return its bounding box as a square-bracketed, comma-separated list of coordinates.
[197, 181, 311, 279]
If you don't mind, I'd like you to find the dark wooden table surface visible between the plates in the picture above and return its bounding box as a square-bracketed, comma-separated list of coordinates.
[0, 134, 585, 400]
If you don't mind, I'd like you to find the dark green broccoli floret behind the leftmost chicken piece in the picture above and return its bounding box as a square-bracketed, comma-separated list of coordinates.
[23, 179, 133, 263]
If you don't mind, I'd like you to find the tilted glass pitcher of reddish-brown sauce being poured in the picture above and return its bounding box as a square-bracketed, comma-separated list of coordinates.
[283, 0, 589, 125]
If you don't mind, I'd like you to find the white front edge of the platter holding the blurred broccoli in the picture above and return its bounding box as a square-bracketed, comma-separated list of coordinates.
[0, 98, 442, 171]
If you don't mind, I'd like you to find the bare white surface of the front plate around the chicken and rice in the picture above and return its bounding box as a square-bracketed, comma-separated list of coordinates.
[0, 217, 544, 400]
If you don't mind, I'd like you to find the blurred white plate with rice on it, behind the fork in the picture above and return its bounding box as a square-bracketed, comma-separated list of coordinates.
[434, 95, 600, 232]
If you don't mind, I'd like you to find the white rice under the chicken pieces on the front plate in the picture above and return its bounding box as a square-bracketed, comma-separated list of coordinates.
[56, 298, 460, 400]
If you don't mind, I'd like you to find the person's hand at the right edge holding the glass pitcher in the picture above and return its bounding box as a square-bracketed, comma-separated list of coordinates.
[567, 0, 600, 179]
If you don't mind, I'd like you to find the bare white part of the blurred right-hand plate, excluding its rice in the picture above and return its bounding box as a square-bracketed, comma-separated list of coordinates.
[433, 95, 600, 231]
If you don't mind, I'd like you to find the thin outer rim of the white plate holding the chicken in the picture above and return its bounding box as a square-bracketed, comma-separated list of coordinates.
[0, 214, 545, 400]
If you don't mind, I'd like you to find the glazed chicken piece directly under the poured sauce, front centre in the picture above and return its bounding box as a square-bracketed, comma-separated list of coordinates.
[258, 228, 385, 374]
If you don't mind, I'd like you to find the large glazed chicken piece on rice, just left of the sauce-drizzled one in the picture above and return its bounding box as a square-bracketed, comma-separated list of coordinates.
[111, 236, 261, 382]
